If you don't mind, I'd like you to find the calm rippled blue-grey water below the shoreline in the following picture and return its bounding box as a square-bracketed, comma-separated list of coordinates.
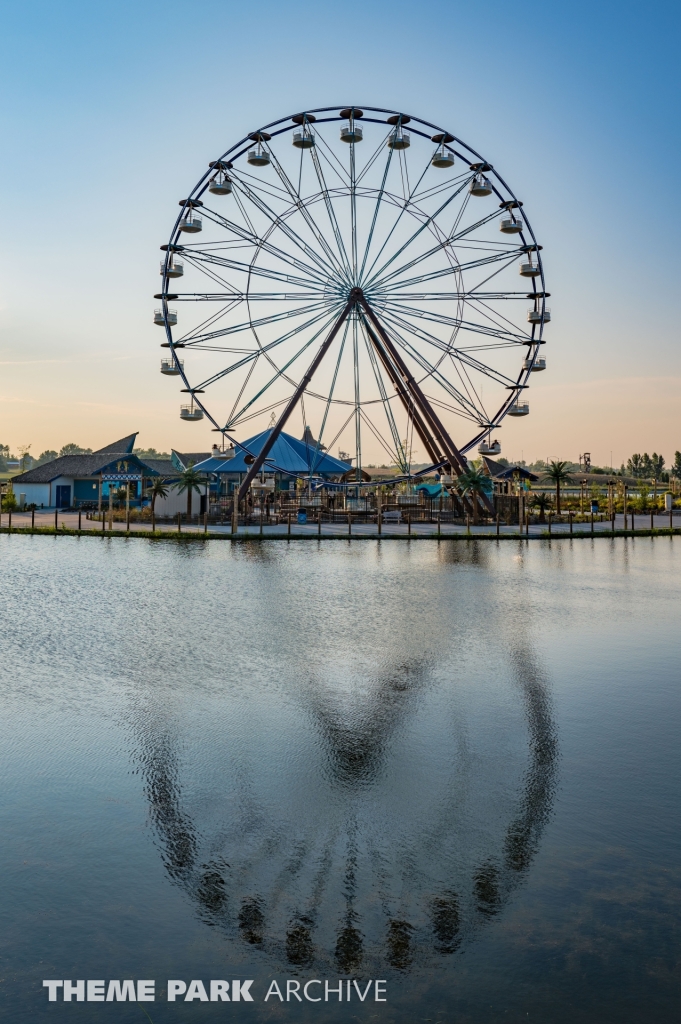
[0, 535, 681, 1024]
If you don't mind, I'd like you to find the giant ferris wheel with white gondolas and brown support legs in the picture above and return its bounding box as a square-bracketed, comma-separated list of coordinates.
[154, 106, 551, 497]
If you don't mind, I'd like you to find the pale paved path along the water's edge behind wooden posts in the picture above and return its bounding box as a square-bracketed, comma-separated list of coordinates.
[0, 510, 681, 540]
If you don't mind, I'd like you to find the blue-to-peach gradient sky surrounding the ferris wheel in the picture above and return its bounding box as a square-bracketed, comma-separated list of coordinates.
[0, 0, 681, 466]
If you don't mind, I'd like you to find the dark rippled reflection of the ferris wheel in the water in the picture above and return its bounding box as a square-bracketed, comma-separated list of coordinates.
[130, 573, 557, 975]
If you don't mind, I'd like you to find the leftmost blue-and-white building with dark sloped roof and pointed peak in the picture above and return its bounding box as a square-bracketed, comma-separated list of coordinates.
[12, 433, 173, 508]
